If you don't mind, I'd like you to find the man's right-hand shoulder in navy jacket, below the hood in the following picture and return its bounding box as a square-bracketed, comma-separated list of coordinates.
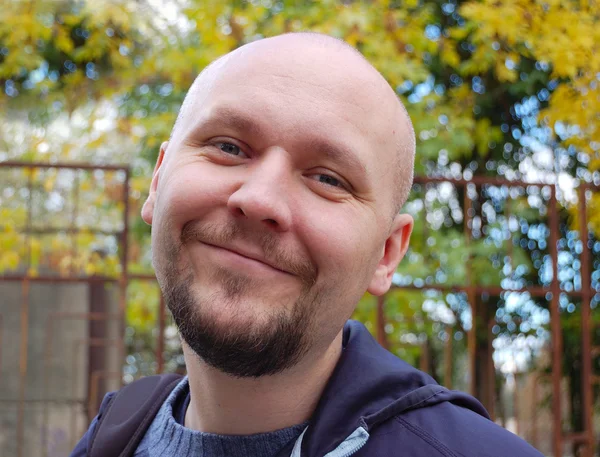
[356, 403, 542, 457]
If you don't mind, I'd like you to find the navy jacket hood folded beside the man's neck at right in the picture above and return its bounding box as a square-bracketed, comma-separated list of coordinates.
[287, 321, 489, 457]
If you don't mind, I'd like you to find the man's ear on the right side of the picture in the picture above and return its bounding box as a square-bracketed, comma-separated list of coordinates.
[367, 214, 414, 295]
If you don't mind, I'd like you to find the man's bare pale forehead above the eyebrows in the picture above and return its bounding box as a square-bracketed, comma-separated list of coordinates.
[185, 42, 397, 137]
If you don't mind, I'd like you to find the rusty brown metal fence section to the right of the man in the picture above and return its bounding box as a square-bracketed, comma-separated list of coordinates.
[408, 176, 600, 456]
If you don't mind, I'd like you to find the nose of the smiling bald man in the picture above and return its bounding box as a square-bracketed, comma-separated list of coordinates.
[227, 151, 292, 232]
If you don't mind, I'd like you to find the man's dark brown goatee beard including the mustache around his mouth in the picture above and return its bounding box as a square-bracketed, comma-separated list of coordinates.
[157, 219, 321, 378]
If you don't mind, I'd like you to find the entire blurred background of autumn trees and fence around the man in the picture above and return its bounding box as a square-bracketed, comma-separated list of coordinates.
[0, 0, 600, 457]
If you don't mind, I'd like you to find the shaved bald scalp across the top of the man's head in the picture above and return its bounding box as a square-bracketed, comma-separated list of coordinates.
[171, 32, 415, 213]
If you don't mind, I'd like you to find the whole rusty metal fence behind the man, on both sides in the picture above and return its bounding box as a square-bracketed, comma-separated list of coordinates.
[0, 162, 600, 457]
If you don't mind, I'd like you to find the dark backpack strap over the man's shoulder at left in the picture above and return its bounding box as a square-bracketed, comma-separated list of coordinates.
[88, 374, 182, 457]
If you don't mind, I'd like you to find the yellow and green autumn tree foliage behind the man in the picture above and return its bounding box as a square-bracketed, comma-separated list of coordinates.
[0, 0, 600, 446]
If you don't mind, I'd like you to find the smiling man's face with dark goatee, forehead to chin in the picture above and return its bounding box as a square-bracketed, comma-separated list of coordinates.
[143, 38, 410, 376]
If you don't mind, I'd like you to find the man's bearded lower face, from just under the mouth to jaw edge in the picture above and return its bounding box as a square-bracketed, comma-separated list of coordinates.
[163, 251, 323, 378]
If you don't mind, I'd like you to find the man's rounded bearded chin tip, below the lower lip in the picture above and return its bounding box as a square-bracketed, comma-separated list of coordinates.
[167, 282, 314, 378]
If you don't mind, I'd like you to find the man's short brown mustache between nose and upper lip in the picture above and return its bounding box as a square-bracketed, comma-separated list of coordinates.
[180, 222, 318, 286]
